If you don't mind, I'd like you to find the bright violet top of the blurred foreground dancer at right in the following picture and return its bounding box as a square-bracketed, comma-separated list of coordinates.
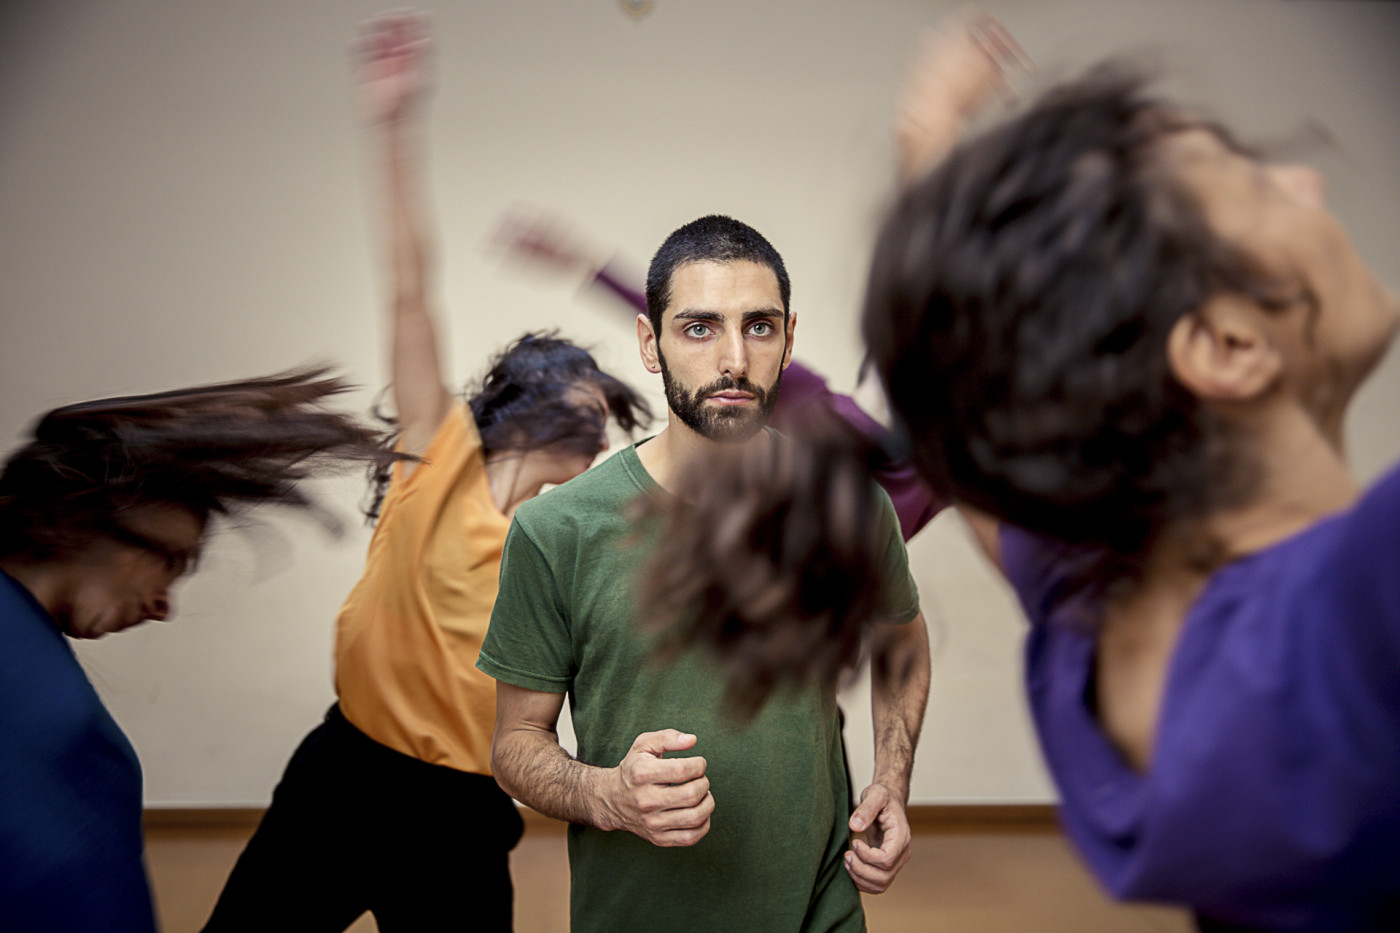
[1001, 469, 1400, 930]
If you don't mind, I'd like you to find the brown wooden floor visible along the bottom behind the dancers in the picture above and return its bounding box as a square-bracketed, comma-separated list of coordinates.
[146, 818, 1193, 933]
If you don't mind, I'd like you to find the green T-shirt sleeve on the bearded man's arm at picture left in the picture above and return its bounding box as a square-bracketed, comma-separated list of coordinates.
[476, 516, 574, 693]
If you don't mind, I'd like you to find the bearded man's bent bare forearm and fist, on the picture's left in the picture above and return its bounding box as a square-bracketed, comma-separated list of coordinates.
[491, 681, 714, 846]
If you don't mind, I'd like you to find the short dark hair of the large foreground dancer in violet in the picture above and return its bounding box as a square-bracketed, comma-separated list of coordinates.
[864, 64, 1309, 590]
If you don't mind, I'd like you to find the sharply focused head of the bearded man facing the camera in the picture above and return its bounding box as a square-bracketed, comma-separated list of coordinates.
[638, 216, 795, 441]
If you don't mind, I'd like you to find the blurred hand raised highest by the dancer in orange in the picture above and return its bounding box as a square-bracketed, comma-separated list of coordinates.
[351, 10, 433, 123]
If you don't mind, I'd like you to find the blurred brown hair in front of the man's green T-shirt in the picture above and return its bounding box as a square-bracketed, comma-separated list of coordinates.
[637, 422, 903, 720]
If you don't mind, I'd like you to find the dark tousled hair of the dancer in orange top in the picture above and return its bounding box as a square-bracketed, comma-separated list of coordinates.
[365, 332, 651, 521]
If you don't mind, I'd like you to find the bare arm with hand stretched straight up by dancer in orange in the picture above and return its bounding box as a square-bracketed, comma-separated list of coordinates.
[356, 11, 451, 454]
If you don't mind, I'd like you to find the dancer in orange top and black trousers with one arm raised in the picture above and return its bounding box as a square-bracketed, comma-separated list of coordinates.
[206, 14, 648, 932]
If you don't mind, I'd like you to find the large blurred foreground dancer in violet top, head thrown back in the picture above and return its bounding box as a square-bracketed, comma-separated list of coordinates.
[864, 49, 1400, 930]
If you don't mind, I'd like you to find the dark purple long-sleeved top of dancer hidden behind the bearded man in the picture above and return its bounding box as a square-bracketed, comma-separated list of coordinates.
[595, 266, 948, 541]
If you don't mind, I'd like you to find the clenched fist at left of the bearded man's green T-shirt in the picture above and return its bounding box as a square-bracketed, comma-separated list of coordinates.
[599, 728, 714, 846]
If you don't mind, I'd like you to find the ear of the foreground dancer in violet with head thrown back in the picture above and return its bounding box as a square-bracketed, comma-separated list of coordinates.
[1166, 294, 1284, 402]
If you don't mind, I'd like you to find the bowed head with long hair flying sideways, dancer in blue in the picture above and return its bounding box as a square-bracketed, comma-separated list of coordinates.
[0, 370, 400, 637]
